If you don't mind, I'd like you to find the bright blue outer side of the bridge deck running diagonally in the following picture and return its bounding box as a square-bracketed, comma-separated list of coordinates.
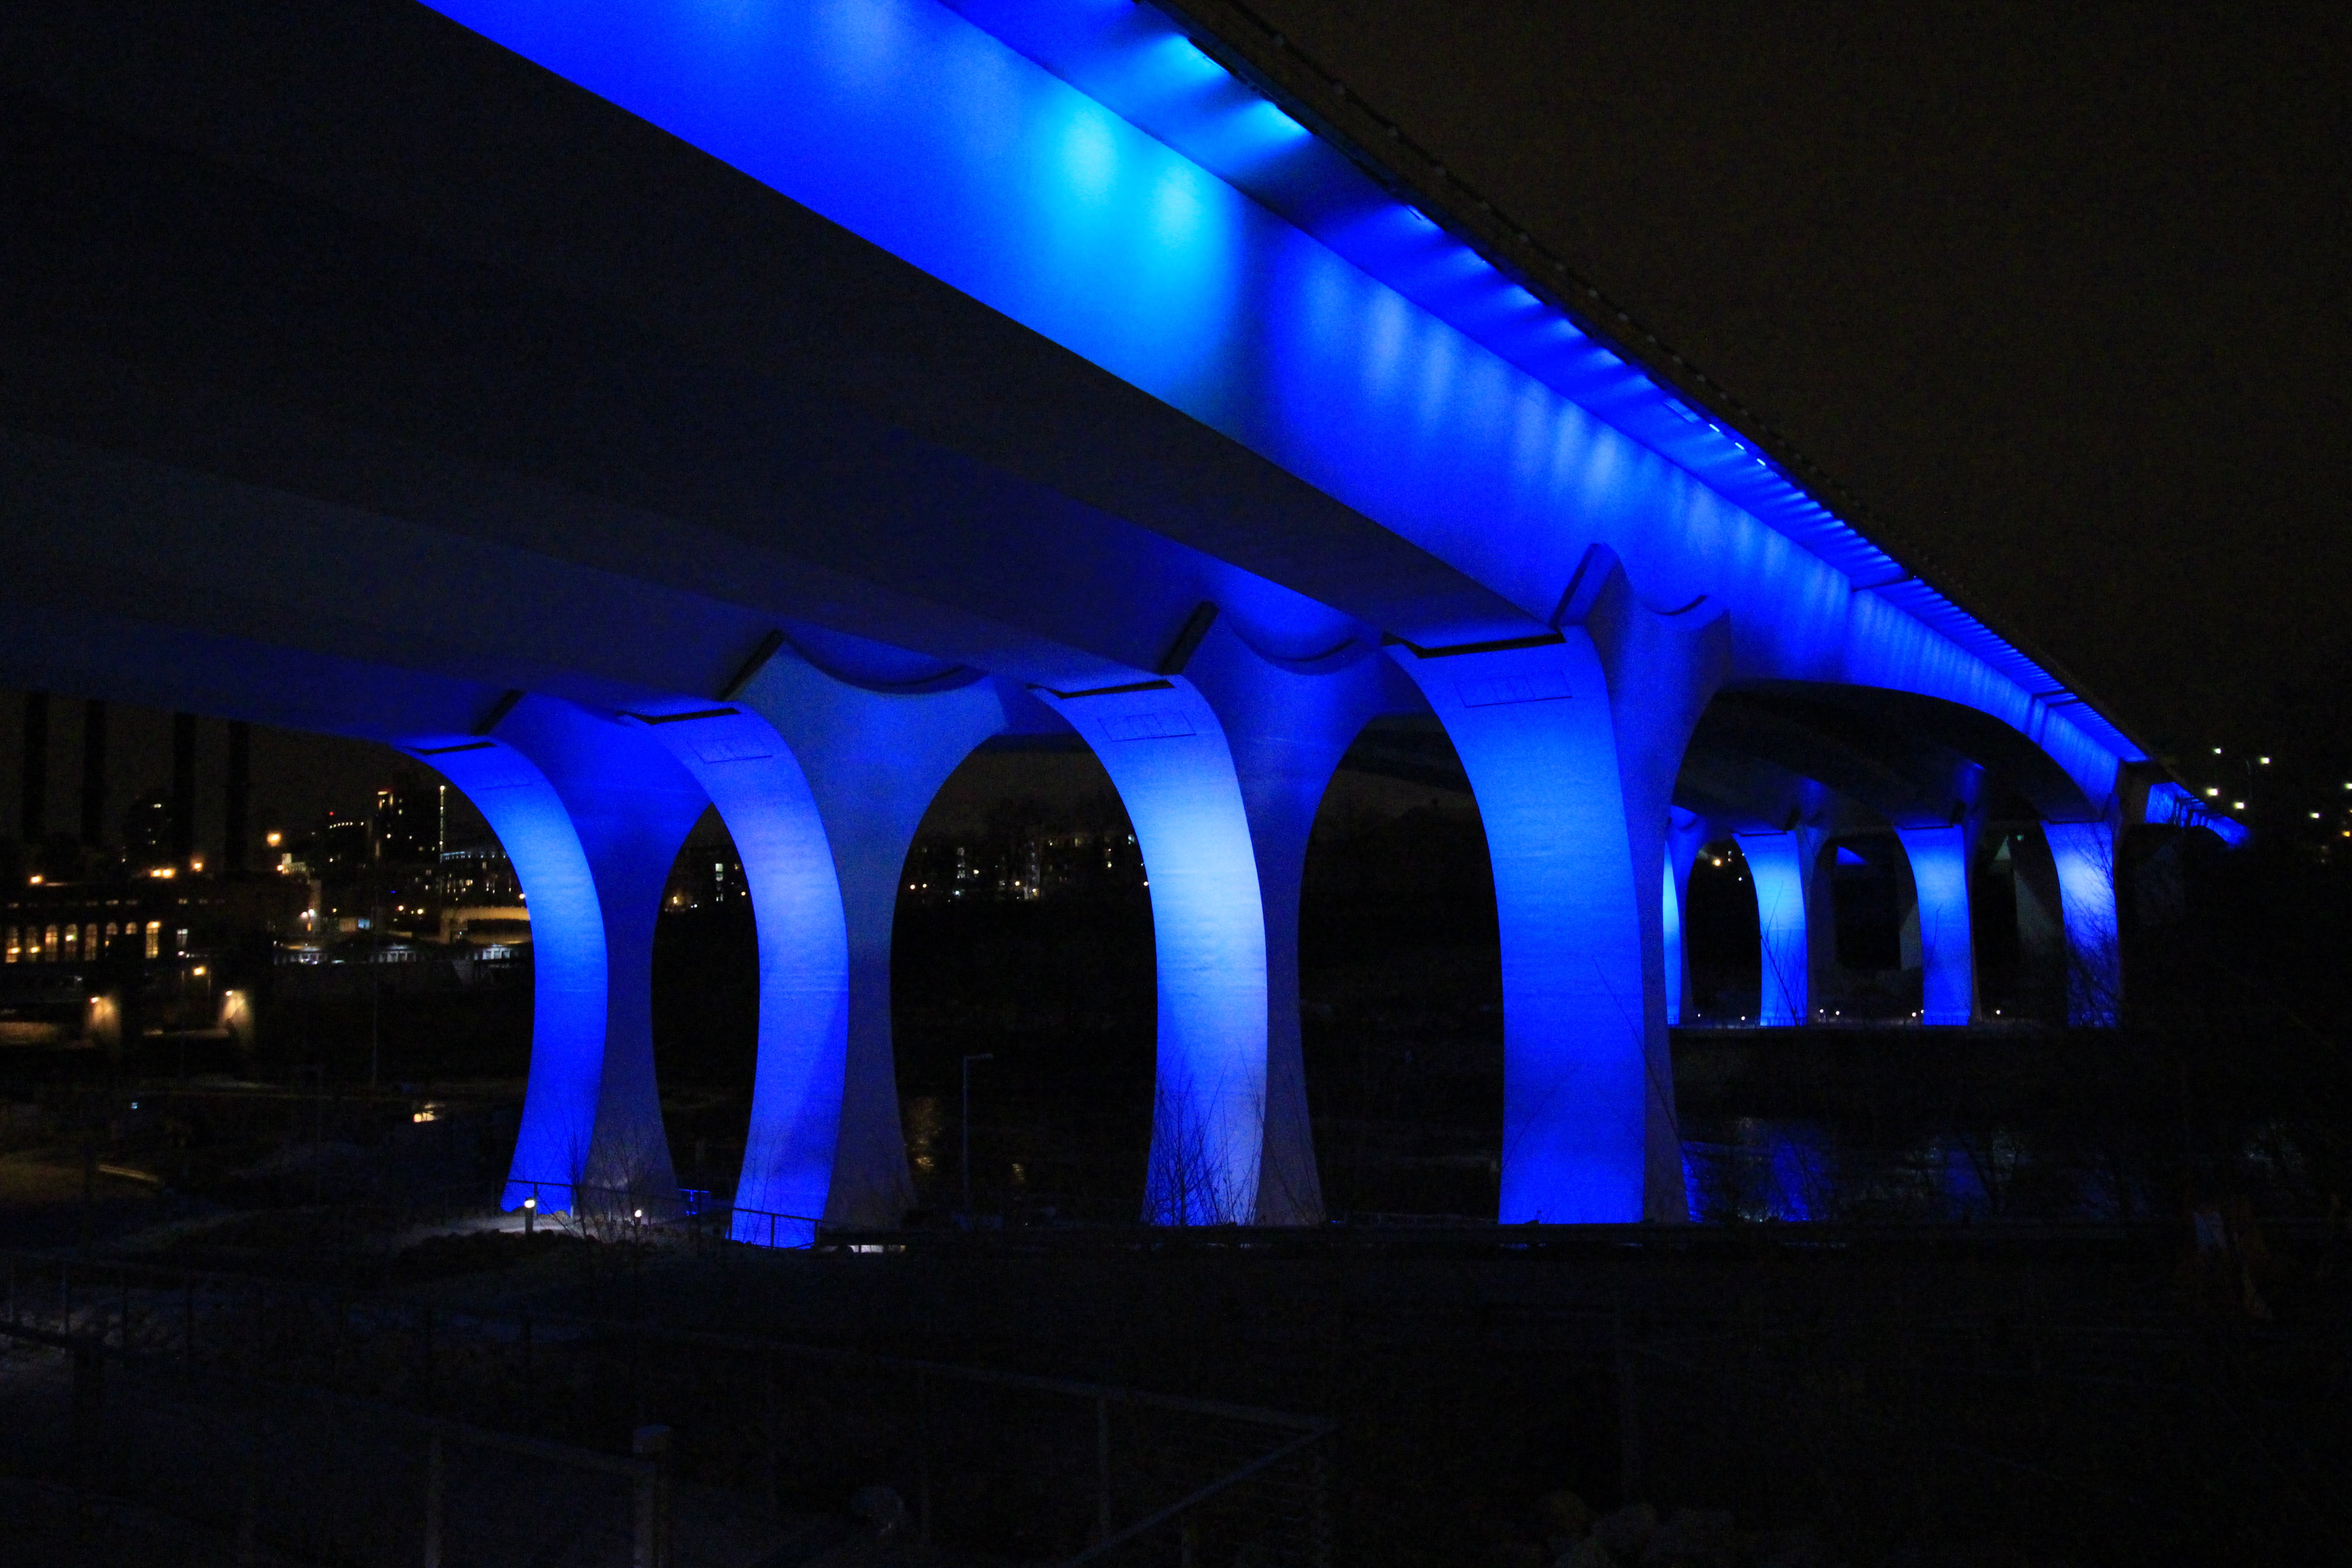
[423, 0, 2138, 804]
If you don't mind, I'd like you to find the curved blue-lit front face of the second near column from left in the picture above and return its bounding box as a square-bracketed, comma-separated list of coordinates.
[647, 703, 849, 1246]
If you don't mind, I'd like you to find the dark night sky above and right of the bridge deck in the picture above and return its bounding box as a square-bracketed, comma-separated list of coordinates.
[1251, 0, 2352, 748]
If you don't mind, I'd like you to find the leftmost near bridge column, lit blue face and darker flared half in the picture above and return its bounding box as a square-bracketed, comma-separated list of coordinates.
[412, 696, 708, 1213]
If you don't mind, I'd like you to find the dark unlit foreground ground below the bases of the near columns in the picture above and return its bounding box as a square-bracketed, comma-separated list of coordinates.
[5, 1208, 2352, 1568]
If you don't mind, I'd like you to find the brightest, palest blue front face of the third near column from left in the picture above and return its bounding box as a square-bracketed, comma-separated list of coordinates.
[1037, 675, 1279, 1225]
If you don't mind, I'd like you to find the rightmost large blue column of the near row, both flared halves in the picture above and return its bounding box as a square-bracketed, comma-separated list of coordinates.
[1392, 550, 1729, 1222]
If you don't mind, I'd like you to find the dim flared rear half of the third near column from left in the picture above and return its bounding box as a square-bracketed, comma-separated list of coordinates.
[1185, 618, 1418, 1225]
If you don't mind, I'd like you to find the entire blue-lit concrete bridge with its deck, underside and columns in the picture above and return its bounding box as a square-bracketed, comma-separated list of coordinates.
[0, 0, 2237, 1241]
